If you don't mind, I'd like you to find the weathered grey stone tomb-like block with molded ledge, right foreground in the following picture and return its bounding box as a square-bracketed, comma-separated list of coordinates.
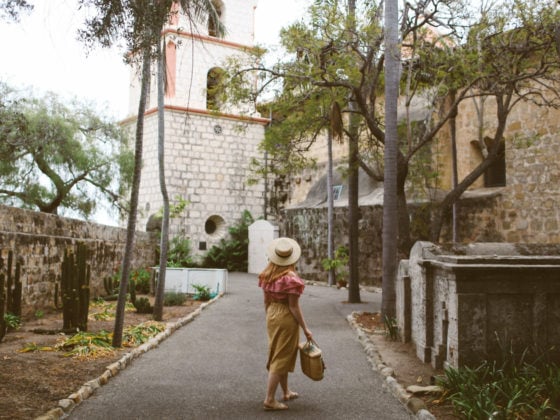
[396, 242, 560, 368]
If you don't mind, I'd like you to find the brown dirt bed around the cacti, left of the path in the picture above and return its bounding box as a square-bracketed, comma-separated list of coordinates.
[0, 300, 200, 420]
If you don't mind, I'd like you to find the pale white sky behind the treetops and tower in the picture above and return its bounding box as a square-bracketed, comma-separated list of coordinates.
[0, 0, 310, 119]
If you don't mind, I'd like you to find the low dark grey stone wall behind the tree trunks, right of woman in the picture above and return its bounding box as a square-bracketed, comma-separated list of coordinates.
[280, 191, 504, 286]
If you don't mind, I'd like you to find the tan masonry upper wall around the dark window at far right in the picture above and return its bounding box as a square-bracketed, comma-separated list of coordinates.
[438, 93, 560, 244]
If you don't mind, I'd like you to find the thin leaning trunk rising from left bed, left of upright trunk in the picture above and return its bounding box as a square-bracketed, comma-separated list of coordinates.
[112, 48, 150, 347]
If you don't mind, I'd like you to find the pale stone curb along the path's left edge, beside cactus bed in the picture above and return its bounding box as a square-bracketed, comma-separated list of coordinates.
[35, 293, 223, 420]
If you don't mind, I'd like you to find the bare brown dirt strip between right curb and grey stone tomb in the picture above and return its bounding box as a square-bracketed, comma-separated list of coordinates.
[354, 312, 460, 420]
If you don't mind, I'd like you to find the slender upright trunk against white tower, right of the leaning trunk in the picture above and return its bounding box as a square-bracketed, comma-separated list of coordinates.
[154, 37, 169, 321]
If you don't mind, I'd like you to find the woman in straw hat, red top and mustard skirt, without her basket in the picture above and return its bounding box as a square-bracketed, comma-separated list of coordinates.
[259, 238, 313, 410]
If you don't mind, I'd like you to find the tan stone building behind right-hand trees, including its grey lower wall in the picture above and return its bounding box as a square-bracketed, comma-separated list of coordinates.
[283, 87, 560, 284]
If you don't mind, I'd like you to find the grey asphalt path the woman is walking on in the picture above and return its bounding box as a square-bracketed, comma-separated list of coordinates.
[69, 273, 412, 420]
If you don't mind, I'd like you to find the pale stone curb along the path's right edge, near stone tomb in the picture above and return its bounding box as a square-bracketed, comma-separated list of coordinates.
[346, 312, 435, 420]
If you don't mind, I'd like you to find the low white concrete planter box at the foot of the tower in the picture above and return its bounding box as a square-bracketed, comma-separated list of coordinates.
[153, 267, 228, 294]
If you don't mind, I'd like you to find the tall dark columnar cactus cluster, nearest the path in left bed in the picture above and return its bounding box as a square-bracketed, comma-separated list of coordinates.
[60, 243, 91, 331]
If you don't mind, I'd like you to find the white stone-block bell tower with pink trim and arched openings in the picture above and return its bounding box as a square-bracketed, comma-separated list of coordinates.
[126, 0, 268, 252]
